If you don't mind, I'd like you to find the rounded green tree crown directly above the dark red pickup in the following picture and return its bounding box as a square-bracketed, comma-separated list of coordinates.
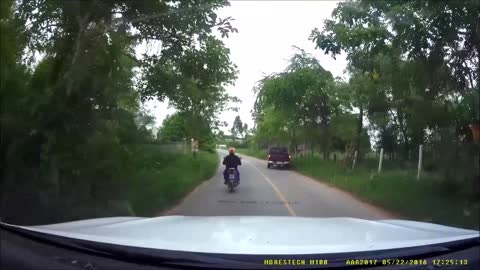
[254, 48, 362, 155]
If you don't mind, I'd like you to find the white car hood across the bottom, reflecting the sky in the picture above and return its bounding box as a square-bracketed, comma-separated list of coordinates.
[6, 216, 479, 254]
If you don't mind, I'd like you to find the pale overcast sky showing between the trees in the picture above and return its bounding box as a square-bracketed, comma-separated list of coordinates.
[146, 0, 347, 131]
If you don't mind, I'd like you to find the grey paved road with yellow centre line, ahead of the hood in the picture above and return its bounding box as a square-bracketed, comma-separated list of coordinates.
[162, 150, 394, 219]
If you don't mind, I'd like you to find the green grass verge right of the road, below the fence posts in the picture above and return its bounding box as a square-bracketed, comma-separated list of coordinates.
[293, 157, 480, 229]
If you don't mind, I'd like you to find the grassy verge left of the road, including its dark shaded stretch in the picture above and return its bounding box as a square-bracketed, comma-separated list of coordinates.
[0, 144, 219, 225]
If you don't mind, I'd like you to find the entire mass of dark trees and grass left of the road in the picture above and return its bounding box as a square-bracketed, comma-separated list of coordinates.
[0, 0, 237, 225]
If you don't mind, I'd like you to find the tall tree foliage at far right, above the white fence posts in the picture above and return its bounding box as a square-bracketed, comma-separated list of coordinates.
[310, 0, 480, 184]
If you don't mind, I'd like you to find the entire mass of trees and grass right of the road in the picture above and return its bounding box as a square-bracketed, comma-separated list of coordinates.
[233, 0, 480, 228]
